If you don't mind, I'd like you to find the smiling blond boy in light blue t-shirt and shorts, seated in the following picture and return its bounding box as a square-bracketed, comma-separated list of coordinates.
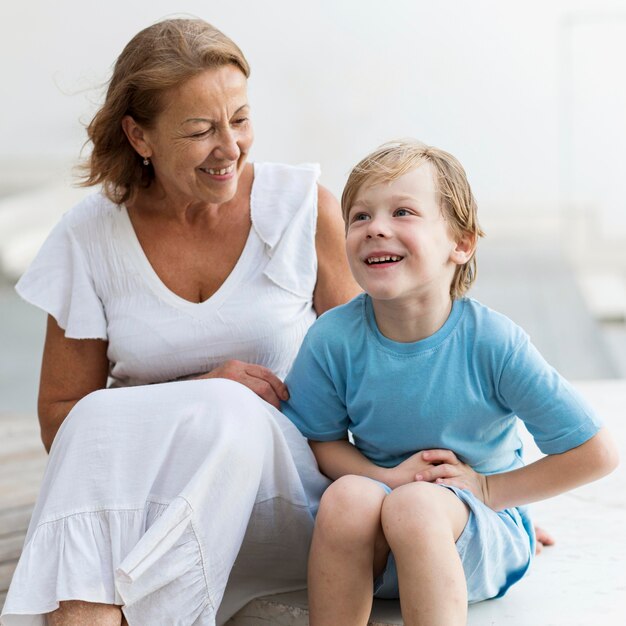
[283, 141, 617, 626]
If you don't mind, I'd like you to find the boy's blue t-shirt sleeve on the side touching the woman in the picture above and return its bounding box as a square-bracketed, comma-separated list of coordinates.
[281, 324, 349, 441]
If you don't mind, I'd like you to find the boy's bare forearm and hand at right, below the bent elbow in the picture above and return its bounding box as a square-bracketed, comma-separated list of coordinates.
[422, 428, 619, 511]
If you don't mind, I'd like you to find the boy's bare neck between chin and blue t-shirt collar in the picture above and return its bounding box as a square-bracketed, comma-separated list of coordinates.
[372, 293, 452, 343]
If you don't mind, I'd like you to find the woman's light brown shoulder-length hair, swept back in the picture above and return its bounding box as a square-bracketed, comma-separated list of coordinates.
[81, 19, 250, 204]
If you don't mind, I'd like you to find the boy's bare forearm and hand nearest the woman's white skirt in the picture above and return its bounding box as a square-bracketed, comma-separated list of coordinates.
[309, 439, 458, 489]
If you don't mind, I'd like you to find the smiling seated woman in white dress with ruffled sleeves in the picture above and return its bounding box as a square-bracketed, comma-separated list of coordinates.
[4, 20, 357, 625]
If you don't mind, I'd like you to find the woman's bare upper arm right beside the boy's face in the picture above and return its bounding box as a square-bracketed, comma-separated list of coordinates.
[313, 185, 361, 315]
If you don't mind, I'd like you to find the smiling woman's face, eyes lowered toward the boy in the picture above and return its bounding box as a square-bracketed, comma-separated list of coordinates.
[144, 65, 253, 204]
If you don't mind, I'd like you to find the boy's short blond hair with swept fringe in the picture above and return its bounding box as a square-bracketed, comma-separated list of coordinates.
[341, 139, 484, 299]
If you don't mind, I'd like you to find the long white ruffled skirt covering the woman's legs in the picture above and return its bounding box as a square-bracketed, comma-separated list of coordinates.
[3, 379, 327, 626]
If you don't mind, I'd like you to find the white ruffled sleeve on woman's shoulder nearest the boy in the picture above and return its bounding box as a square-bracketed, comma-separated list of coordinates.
[250, 163, 320, 298]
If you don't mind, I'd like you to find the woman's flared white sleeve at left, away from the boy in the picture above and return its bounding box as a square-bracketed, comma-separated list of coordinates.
[15, 217, 107, 339]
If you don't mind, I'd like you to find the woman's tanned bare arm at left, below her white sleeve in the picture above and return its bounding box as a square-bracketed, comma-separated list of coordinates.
[38, 316, 109, 452]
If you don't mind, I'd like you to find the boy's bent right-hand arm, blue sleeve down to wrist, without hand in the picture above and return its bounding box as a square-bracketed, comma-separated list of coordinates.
[446, 329, 618, 510]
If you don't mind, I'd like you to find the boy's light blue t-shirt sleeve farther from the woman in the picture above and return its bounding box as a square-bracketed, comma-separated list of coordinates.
[498, 336, 602, 454]
